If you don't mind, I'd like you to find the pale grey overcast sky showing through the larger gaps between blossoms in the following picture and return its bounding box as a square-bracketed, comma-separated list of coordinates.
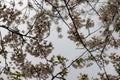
[0, 0, 119, 80]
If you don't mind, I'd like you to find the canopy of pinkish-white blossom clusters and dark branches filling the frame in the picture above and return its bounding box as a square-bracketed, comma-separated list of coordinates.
[0, 0, 120, 80]
